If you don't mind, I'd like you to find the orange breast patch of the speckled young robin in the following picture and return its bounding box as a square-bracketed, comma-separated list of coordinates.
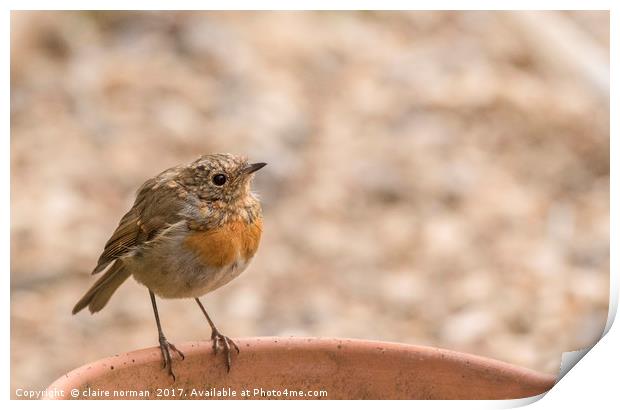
[185, 219, 263, 268]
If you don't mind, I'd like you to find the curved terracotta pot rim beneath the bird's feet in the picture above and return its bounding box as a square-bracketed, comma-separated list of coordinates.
[48, 337, 555, 399]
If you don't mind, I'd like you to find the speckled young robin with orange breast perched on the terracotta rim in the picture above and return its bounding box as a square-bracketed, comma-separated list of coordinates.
[73, 154, 267, 380]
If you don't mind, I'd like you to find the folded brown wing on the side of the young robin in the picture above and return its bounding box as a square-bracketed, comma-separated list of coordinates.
[93, 177, 181, 274]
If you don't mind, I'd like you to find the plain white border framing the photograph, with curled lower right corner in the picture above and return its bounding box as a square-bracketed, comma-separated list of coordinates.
[0, 0, 620, 409]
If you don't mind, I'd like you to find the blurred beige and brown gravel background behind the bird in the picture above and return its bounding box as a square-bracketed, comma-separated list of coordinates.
[11, 12, 609, 394]
